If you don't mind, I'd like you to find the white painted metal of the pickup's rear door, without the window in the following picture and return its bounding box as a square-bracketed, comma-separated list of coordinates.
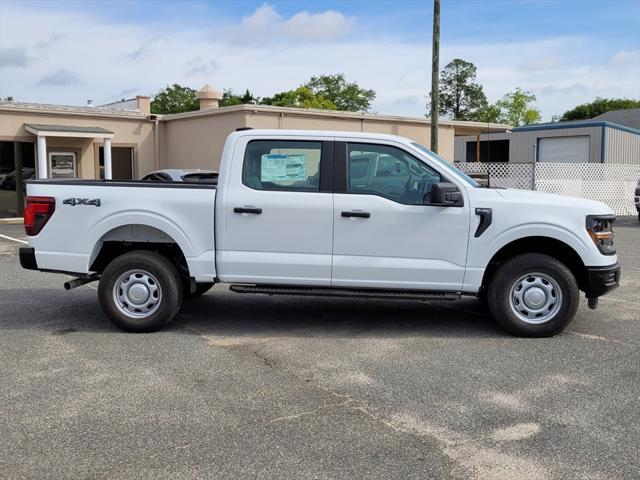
[216, 132, 333, 286]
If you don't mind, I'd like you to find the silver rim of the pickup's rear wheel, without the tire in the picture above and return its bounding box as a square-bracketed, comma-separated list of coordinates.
[113, 270, 162, 318]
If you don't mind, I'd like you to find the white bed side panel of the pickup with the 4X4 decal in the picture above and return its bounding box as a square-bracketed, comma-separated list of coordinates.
[27, 182, 216, 282]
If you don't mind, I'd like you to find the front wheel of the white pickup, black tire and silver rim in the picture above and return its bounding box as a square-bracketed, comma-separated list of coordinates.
[487, 253, 580, 337]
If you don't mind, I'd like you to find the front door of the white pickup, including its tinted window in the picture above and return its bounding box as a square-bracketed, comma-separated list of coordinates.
[332, 142, 469, 291]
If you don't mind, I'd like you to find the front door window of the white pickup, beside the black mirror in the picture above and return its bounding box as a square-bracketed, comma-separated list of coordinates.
[347, 143, 441, 205]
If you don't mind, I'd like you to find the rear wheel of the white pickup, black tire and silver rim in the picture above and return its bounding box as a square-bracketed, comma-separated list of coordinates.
[98, 250, 183, 332]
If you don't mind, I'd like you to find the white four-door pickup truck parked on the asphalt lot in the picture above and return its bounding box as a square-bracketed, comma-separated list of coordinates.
[20, 129, 620, 336]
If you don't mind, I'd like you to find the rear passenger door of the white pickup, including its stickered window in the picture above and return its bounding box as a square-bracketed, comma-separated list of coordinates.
[216, 137, 333, 286]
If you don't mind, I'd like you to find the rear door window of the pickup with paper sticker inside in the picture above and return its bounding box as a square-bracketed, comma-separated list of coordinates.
[242, 140, 322, 192]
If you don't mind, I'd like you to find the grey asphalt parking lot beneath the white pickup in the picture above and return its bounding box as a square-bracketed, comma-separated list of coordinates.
[0, 218, 640, 479]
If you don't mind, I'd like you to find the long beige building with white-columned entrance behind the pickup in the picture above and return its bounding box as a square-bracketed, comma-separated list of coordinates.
[0, 85, 508, 218]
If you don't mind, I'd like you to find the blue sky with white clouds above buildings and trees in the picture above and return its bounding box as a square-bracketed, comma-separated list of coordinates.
[0, 0, 640, 120]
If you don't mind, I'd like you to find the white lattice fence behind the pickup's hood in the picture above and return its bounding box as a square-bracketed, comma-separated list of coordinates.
[456, 162, 640, 215]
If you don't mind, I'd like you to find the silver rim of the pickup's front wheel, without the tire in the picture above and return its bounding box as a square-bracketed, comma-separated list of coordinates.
[509, 272, 562, 325]
